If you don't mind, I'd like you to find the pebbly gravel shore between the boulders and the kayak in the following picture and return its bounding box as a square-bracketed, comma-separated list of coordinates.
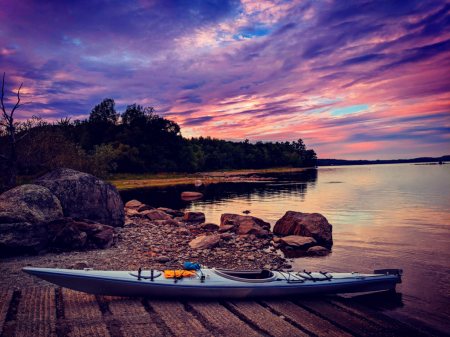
[0, 213, 290, 289]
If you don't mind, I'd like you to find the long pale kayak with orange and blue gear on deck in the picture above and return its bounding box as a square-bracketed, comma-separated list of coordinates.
[23, 267, 403, 298]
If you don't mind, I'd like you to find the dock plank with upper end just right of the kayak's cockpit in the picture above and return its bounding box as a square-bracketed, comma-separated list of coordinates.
[261, 299, 352, 337]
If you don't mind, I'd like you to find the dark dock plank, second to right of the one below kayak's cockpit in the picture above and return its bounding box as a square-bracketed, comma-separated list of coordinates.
[295, 298, 389, 336]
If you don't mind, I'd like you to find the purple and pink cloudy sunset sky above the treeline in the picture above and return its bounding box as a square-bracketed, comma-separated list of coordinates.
[0, 0, 450, 159]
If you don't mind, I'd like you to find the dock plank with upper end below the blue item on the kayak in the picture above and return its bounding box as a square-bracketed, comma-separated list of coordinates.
[187, 301, 261, 337]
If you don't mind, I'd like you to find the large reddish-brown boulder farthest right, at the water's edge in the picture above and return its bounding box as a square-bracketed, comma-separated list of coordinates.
[273, 211, 333, 245]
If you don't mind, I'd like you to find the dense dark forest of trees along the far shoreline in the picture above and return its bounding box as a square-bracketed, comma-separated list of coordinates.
[0, 98, 317, 184]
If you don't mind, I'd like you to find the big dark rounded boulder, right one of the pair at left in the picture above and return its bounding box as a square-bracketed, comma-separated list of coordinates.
[34, 168, 125, 227]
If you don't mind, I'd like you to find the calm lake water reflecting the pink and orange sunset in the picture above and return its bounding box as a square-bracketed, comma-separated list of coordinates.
[121, 164, 450, 333]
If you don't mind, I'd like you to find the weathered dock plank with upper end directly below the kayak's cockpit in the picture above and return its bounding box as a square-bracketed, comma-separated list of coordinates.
[226, 300, 307, 337]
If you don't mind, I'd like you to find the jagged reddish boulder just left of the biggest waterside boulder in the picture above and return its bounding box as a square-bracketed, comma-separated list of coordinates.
[219, 213, 270, 237]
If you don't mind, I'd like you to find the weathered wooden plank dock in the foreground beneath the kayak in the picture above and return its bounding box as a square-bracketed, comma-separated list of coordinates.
[0, 287, 428, 337]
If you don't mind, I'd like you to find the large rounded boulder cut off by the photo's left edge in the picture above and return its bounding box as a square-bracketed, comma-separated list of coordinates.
[0, 184, 63, 256]
